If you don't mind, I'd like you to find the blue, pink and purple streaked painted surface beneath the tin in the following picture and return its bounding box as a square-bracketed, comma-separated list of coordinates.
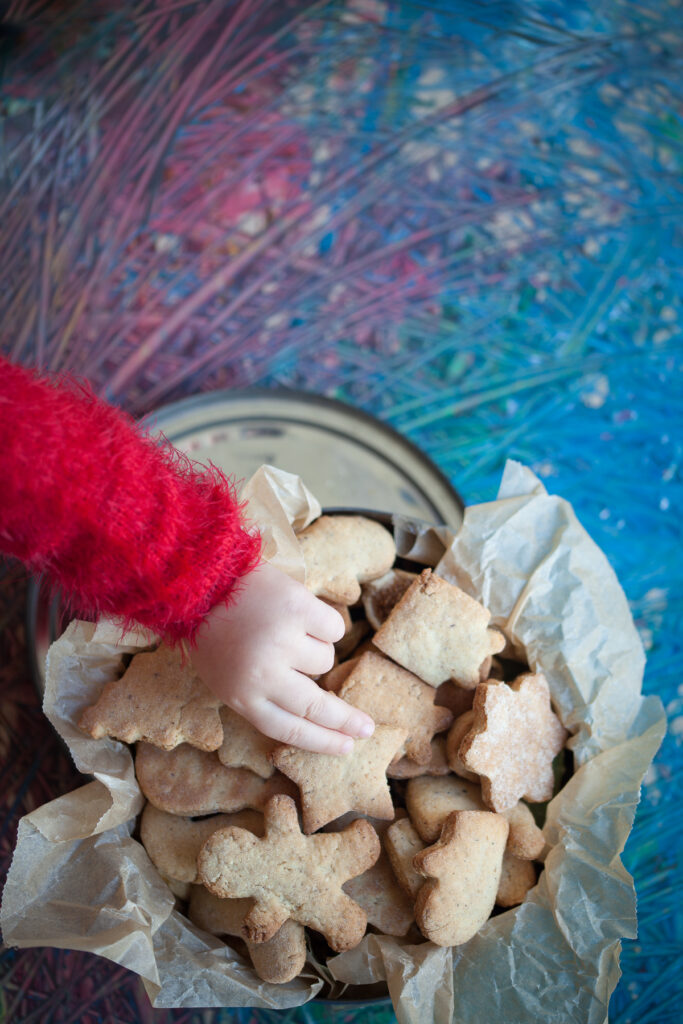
[0, 0, 683, 1024]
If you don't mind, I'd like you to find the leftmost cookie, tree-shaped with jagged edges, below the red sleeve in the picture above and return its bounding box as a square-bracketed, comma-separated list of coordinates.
[78, 644, 223, 751]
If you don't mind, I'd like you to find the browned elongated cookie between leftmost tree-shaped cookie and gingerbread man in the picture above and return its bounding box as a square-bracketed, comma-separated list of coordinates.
[135, 743, 296, 817]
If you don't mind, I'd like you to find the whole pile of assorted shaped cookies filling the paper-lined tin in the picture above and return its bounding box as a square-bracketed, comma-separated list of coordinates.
[79, 515, 567, 983]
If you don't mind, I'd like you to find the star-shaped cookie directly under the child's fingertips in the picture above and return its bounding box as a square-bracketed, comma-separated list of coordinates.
[271, 725, 408, 834]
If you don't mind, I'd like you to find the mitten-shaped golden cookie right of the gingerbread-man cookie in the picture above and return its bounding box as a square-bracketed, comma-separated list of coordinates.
[413, 811, 508, 946]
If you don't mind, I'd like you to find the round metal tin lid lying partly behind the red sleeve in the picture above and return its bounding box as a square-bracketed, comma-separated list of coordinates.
[27, 390, 463, 692]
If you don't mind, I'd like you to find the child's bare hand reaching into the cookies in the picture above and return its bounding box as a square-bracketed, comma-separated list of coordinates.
[191, 562, 374, 754]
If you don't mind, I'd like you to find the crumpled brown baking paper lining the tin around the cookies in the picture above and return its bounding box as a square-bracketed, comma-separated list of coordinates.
[1, 463, 666, 1024]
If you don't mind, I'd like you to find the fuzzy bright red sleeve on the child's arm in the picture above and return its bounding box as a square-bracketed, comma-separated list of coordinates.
[0, 357, 260, 640]
